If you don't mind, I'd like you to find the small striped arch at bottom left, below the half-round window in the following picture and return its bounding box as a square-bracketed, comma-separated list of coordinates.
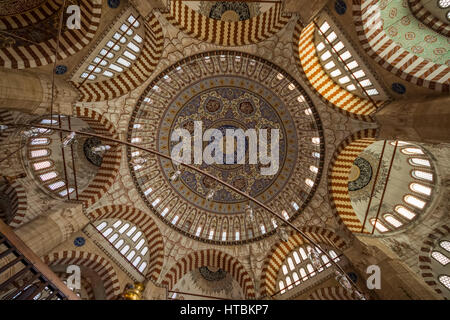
[43, 250, 120, 300]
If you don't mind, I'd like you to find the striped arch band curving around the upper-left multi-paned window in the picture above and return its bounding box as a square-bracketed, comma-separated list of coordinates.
[74, 14, 164, 102]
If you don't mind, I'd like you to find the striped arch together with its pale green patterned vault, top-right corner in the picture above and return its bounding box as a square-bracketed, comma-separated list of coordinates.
[353, 0, 450, 92]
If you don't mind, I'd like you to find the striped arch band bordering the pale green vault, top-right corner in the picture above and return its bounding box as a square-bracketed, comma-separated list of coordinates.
[353, 0, 450, 92]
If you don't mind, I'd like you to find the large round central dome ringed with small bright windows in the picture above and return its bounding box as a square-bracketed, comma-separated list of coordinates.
[128, 51, 323, 243]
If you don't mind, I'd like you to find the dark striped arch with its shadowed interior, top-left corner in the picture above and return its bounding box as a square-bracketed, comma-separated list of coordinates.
[0, 0, 102, 69]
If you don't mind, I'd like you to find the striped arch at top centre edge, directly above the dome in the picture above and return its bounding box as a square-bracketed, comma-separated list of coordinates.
[163, 1, 290, 46]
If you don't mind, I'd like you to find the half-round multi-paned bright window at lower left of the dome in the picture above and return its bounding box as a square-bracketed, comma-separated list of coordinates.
[95, 219, 148, 273]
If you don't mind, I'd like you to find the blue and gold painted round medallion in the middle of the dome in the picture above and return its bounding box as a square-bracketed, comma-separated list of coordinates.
[158, 76, 297, 213]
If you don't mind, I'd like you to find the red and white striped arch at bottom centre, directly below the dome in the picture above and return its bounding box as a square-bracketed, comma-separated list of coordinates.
[162, 249, 255, 299]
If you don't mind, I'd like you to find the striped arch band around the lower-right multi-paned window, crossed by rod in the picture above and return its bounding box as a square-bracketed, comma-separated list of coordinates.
[260, 227, 347, 297]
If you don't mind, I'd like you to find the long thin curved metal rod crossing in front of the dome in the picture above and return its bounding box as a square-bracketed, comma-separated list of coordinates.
[6, 123, 361, 294]
